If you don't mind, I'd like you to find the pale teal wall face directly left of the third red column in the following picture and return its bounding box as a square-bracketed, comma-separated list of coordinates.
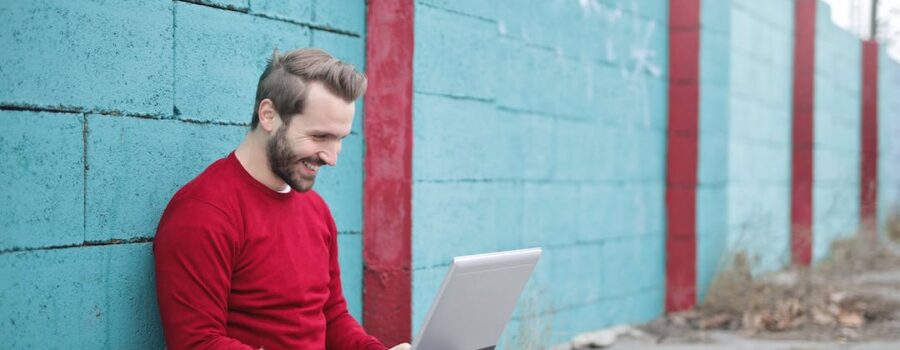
[724, 0, 794, 271]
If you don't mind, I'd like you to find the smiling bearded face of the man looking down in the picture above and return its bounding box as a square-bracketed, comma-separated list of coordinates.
[266, 82, 355, 192]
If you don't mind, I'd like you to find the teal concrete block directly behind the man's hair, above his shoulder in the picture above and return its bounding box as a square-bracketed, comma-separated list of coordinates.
[175, 3, 310, 124]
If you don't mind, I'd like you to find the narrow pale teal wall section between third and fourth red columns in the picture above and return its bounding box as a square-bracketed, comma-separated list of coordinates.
[812, 2, 862, 261]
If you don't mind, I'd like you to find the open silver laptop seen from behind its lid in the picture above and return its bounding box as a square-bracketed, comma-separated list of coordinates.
[412, 248, 541, 350]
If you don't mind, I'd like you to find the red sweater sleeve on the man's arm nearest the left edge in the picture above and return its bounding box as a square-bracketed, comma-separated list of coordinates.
[153, 198, 253, 350]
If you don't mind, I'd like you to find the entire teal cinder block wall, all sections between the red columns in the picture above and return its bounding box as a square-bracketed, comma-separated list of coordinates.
[0, 0, 900, 349]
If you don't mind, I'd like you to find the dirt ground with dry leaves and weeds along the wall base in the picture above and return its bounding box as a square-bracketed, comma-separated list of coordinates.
[564, 215, 900, 349]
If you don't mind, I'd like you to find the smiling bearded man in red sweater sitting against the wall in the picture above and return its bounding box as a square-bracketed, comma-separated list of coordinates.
[153, 49, 409, 350]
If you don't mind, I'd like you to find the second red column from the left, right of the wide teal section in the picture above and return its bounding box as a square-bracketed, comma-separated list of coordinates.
[666, 0, 700, 311]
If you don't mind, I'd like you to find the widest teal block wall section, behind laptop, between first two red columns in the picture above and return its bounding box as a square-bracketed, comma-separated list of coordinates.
[412, 0, 668, 349]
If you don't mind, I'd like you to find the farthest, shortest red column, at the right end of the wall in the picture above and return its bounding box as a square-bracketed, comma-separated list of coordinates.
[859, 40, 878, 234]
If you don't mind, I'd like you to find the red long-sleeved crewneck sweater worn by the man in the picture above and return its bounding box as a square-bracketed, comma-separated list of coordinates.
[153, 153, 385, 350]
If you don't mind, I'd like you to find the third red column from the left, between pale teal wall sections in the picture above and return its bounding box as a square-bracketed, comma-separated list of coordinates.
[791, 0, 817, 265]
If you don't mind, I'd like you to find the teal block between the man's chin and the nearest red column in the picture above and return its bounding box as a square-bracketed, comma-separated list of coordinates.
[313, 135, 364, 232]
